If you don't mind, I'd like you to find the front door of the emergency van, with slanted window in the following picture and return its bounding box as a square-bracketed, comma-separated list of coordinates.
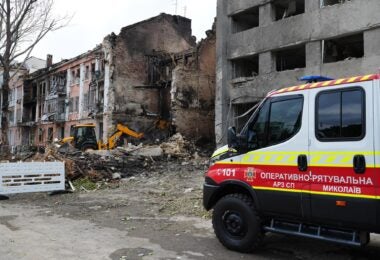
[248, 91, 310, 217]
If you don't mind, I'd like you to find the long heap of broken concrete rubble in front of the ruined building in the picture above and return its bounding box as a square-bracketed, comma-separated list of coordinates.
[17, 134, 210, 186]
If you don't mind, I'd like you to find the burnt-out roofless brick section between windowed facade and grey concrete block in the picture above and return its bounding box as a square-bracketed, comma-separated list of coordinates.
[95, 14, 215, 142]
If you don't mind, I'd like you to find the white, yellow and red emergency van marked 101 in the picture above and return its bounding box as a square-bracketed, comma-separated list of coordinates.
[203, 74, 380, 252]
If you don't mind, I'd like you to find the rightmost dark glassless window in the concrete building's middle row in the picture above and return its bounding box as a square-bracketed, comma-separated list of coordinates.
[322, 33, 364, 63]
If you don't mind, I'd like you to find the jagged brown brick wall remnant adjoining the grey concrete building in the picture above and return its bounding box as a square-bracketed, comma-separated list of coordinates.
[171, 28, 215, 140]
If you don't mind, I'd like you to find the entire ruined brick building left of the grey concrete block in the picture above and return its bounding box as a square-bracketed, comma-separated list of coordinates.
[0, 14, 215, 152]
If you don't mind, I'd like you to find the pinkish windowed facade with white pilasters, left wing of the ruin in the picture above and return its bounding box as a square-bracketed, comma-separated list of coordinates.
[20, 46, 104, 146]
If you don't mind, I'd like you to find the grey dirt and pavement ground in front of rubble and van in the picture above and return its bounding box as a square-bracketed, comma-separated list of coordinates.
[0, 160, 380, 260]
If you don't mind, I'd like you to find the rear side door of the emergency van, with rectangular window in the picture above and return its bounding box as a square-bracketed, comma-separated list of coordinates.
[309, 81, 379, 228]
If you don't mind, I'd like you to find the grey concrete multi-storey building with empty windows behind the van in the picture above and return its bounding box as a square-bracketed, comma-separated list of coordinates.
[215, 0, 380, 143]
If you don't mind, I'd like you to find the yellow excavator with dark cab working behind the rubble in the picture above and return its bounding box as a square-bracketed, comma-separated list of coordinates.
[60, 124, 144, 151]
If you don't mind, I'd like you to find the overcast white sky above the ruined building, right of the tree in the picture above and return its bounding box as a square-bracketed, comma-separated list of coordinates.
[31, 0, 216, 62]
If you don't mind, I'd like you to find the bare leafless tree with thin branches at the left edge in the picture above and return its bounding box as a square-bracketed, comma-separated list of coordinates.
[0, 0, 69, 145]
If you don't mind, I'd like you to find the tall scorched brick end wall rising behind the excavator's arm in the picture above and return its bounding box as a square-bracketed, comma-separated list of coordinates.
[103, 14, 195, 136]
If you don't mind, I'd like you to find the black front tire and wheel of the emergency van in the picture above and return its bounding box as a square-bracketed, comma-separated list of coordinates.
[212, 193, 264, 253]
